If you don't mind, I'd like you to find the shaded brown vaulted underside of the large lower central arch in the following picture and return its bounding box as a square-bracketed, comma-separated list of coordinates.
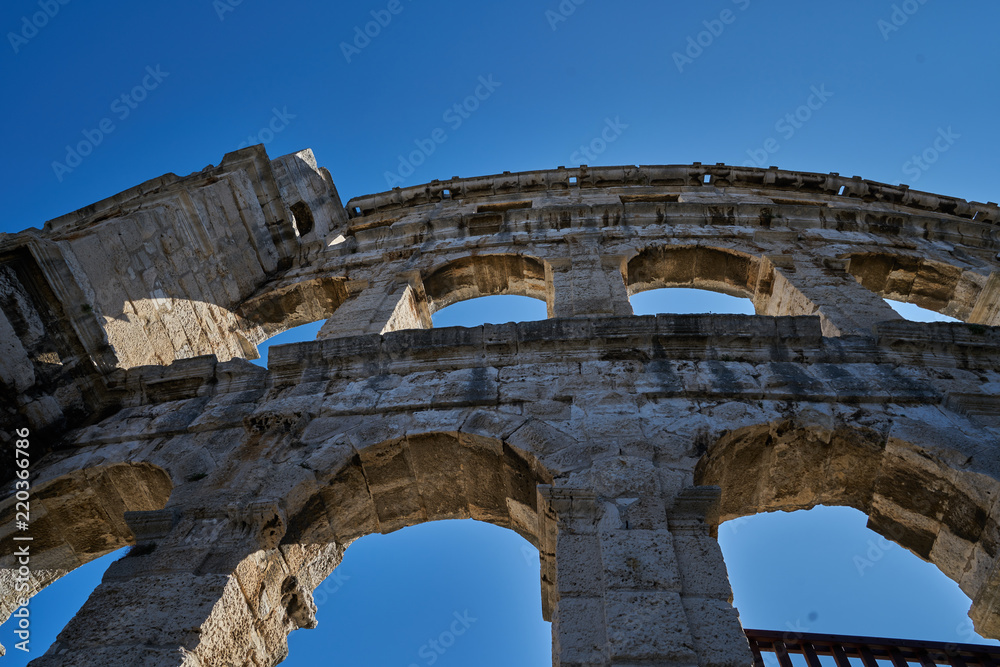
[283, 432, 552, 546]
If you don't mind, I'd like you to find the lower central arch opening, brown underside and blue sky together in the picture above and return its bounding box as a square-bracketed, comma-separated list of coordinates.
[282, 432, 552, 665]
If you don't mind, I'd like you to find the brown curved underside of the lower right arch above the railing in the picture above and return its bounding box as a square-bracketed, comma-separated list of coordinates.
[695, 421, 1000, 637]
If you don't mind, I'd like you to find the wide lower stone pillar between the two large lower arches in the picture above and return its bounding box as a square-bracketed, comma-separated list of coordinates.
[542, 487, 752, 667]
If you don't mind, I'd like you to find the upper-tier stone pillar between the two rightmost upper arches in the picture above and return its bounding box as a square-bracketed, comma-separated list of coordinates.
[754, 255, 902, 336]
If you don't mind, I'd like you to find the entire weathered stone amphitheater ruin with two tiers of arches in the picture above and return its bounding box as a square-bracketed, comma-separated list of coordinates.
[0, 146, 1000, 667]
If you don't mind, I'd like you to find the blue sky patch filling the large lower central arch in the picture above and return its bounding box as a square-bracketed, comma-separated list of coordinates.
[282, 520, 552, 667]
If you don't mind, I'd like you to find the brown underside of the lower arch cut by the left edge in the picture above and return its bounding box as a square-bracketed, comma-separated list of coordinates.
[0, 463, 173, 644]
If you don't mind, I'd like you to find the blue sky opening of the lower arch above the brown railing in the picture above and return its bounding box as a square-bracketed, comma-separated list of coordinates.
[719, 505, 1000, 644]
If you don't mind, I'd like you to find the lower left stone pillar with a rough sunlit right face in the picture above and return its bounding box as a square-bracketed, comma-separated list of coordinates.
[31, 501, 334, 667]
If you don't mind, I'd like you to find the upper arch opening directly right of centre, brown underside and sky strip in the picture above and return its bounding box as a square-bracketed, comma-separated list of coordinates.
[625, 246, 771, 314]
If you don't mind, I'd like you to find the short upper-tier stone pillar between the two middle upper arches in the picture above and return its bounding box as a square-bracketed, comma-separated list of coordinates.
[546, 234, 632, 317]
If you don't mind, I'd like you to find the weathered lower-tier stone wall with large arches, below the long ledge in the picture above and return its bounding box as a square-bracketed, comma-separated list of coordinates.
[3, 316, 1000, 665]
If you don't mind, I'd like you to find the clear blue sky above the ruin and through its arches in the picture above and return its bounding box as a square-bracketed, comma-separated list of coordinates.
[0, 0, 1000, 667]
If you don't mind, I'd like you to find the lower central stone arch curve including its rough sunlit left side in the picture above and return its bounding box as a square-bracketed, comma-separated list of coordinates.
[229, 427, 554, 664]
